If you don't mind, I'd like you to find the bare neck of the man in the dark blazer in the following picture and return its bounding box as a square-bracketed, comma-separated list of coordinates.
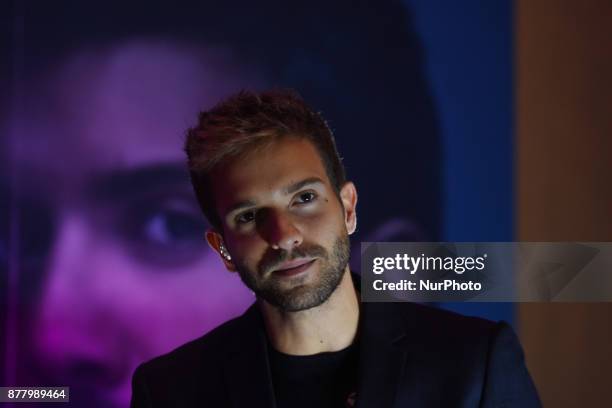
[260, 267, 359, 355]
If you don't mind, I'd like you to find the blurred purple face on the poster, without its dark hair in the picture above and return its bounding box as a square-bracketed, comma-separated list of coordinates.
[5, 42, 262, 407]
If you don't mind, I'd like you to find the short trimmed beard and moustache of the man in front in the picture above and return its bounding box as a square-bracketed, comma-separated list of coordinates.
[235, 233, 350, 312]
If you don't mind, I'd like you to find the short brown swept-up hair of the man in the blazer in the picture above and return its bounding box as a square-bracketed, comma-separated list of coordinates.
[185, 89, 346, 230]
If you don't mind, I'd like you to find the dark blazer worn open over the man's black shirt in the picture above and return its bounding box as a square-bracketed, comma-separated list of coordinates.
[131, 303, 541, 408]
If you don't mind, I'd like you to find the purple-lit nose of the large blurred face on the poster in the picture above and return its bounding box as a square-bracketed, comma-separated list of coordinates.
[32, 215, 123, 384]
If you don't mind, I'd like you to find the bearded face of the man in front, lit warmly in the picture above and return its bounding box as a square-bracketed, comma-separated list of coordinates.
[211, 137, 355, 311]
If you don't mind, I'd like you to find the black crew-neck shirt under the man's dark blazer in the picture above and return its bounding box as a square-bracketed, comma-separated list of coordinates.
[268, 343, 359, 408]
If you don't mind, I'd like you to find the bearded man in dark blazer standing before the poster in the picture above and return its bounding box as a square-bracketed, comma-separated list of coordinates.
[132, 91, 539, 408]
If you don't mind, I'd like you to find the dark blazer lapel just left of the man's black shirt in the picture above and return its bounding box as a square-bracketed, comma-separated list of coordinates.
[223, 304, 274, 408]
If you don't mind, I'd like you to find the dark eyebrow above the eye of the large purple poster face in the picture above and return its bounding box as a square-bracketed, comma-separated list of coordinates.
[86, 163, 190, 199]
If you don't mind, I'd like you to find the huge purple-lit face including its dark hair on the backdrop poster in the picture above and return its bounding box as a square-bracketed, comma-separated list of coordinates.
[0, 2, 440, 407]
